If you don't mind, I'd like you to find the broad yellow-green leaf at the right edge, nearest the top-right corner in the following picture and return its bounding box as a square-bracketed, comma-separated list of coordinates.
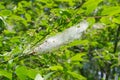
[102, 6, 120, 16]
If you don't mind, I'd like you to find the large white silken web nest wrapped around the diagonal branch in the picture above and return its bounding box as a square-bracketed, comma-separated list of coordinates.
[33, 20, 89, 53]
